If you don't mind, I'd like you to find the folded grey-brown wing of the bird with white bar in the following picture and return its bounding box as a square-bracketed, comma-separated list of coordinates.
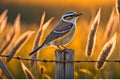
[44, 24, 74, 43]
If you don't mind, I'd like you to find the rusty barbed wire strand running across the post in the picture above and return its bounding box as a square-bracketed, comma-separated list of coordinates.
[0, 55, 120, 63]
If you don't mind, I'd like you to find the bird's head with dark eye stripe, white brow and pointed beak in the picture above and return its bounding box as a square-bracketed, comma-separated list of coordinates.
[62, 11, 82, 23]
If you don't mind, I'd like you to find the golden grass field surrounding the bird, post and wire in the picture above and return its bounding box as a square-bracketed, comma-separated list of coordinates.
[0, 0, 120, 79]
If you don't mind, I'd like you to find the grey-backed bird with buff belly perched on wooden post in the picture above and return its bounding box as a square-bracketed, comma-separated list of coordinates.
[29, 11, 82, 56]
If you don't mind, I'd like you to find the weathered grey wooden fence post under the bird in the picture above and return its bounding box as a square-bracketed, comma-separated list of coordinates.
[55, 49, 74, 79]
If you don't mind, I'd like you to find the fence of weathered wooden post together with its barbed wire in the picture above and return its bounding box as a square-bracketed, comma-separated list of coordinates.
[0, 49, 120, 79]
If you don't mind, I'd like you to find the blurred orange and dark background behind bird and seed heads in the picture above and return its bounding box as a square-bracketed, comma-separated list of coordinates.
[0, 0, 120, 78]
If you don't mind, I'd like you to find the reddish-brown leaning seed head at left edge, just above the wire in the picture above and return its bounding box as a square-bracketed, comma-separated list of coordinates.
[0, 30, 15, 54]
